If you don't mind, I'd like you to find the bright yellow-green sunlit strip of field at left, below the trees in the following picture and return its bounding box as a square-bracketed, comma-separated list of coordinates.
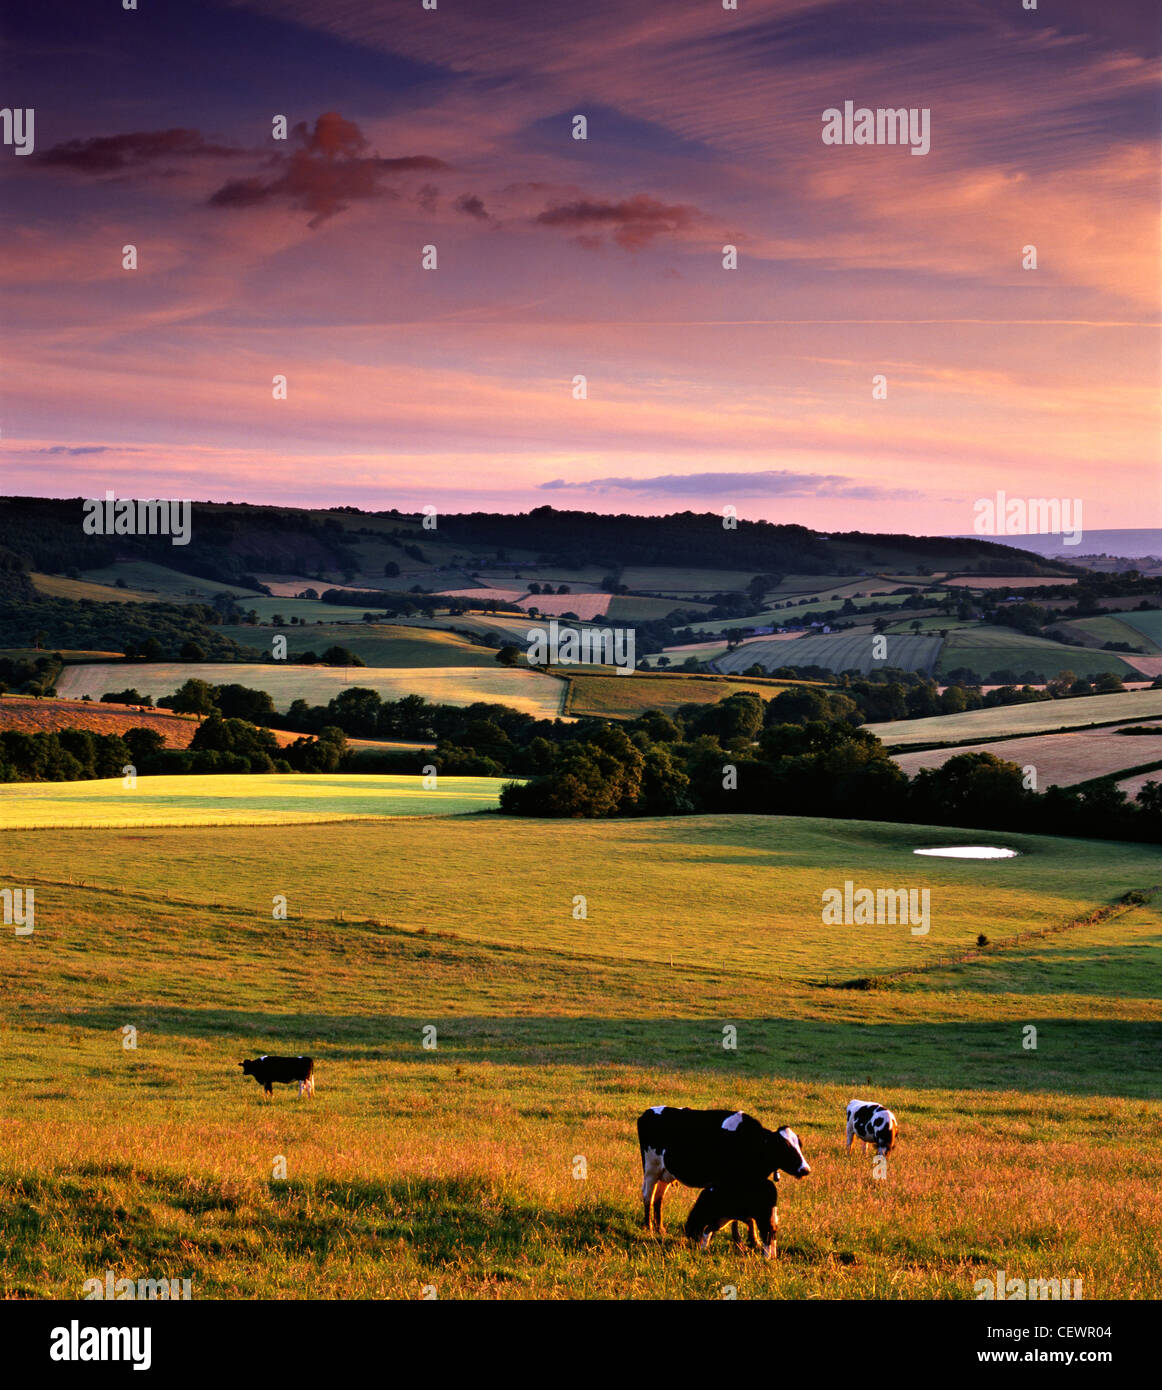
[0, 773, 505, 830]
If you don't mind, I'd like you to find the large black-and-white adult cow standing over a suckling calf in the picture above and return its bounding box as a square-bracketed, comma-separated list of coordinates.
[638, 1105, 810, 1234]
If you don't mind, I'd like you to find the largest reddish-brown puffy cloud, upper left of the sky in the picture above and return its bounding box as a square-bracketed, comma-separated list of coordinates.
[210, 111, 449, 227]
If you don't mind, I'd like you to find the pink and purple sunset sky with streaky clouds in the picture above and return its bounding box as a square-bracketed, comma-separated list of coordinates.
[0, 0, 1162, 534]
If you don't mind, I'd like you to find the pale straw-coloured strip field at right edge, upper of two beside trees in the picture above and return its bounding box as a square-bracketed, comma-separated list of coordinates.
[865, 689, 1162, 748]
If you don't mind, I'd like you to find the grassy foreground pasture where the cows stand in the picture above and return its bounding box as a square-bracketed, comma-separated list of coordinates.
[0, 817, 1162, 1298]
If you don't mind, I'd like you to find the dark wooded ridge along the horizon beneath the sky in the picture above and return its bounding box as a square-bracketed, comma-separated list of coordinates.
[0, 498, 1070, 592]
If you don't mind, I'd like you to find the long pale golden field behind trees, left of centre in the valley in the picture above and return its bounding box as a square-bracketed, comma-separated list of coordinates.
[57, 660, 566, 719]
